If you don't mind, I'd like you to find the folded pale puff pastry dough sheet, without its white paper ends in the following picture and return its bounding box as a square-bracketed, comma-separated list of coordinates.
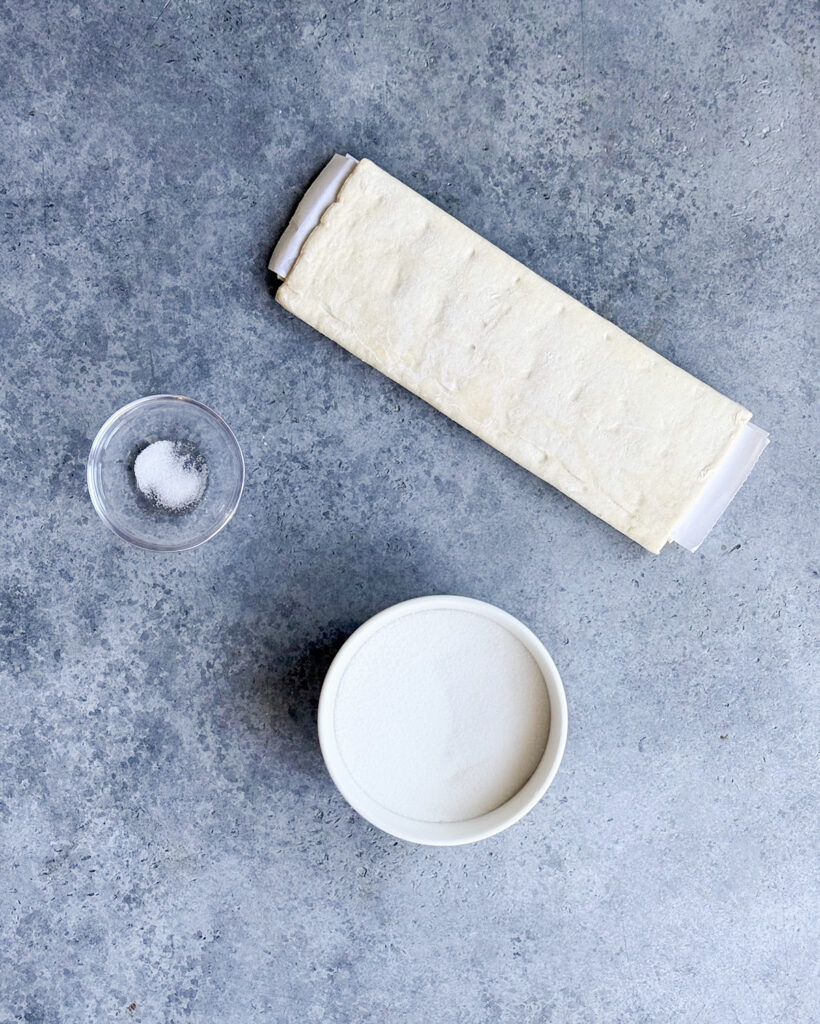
[276, 160, 750, 553]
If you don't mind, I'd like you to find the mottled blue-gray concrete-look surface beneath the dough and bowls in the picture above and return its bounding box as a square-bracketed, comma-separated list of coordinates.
[0, 0, 818, 1024]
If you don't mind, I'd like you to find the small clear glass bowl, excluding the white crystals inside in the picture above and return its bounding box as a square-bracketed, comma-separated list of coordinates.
[87, 394, 245, 551]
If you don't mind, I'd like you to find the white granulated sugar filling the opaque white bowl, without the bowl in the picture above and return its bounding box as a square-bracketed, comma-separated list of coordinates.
[334, 610, 550, 821]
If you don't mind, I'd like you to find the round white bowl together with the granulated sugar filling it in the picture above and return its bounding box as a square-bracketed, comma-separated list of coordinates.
[318, 596, 567, 846]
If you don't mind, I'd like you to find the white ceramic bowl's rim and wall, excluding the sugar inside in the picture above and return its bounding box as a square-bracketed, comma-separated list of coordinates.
[318, 596, 567, 846]
